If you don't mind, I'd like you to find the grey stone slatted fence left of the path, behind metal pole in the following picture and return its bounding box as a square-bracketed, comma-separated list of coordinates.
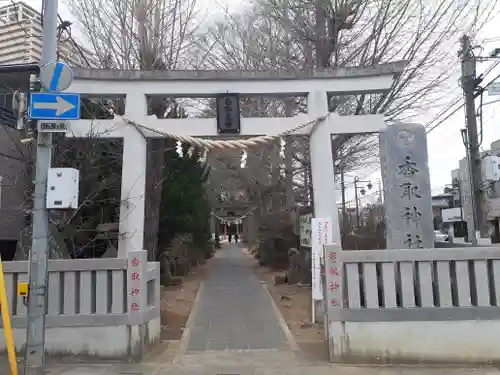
[3, 259, 160, 328]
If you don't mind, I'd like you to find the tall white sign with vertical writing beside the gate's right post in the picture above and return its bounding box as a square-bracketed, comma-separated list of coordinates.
[311, 218, 333, 301]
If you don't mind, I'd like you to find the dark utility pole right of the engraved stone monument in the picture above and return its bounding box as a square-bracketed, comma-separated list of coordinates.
[459, 35, 488, 241]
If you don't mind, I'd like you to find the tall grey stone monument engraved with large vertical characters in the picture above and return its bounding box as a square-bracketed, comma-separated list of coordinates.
[379, 124, 434, 249]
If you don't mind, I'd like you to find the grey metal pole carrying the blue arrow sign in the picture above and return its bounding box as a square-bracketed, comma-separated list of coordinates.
[25, 0, 58, 375]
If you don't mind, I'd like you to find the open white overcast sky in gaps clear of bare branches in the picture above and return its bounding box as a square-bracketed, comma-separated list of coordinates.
[11, 0, 500, 207]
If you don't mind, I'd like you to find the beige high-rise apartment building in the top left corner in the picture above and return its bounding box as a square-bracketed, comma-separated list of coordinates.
[0, 3, 90, 67]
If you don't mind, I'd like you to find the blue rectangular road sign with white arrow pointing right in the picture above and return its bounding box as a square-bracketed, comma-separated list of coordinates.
[29, 92, 80, 120]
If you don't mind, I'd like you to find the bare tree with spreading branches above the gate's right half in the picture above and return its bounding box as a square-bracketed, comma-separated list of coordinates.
[193, 0, 496, 206]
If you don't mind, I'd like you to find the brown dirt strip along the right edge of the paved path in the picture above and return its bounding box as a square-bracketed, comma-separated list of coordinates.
[247, 253, 328, 361]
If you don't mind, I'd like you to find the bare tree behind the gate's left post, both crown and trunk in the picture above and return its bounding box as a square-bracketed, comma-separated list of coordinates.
[61, 0, 202, 260]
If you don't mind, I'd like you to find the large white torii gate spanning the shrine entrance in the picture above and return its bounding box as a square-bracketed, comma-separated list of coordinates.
[66, 62, 406, 258]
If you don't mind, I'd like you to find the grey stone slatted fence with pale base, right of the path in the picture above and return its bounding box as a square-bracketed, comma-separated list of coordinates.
[325, 246, 500, 363]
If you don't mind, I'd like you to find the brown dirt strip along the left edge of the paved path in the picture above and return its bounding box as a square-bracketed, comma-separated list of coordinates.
[161, 254, 217, 341]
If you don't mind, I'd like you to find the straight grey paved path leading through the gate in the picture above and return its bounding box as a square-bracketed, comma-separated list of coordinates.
[187, 244, 289, 353]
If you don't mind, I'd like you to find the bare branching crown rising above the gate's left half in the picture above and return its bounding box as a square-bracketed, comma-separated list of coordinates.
[67, 0, 196, 70]
